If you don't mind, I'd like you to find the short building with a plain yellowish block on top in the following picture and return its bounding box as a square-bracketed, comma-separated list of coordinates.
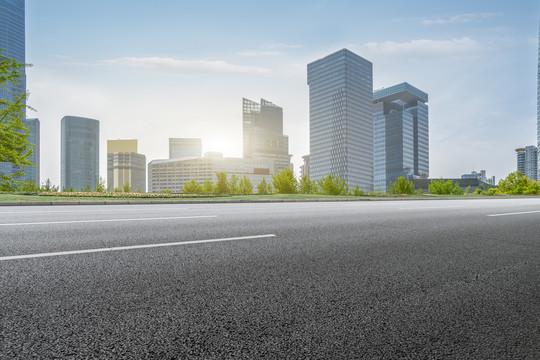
[107, 140, 146, 192]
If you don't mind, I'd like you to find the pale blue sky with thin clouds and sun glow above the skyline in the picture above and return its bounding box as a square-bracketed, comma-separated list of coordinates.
[26, 0, 540, 184]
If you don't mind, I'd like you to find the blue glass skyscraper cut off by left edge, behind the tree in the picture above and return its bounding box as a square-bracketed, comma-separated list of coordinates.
[0, 0, 26, 112]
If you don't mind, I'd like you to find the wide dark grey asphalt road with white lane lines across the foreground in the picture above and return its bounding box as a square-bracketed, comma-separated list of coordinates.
[0, 198, 540, 359]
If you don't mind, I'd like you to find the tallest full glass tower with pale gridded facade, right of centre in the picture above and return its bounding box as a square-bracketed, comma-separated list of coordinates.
[307, 49, 373, 191]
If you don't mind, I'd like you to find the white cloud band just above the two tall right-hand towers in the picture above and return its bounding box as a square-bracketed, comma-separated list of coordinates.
[364, 37, 480, 56]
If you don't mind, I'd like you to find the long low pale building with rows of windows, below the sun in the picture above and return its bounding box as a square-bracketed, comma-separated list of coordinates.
[148, 153, 275, 193]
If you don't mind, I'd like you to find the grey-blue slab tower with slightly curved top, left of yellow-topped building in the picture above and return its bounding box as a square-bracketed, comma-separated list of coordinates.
[61, 116, 99, 190]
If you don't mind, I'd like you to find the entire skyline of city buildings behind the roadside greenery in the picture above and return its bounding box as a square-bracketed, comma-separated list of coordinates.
[4, 0, 540, 192]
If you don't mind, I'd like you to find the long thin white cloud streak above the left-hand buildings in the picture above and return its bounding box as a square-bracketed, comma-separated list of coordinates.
[104, 57, 270, 74]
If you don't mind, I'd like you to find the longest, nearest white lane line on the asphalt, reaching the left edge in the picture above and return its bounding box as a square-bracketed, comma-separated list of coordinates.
[0, 234, 276, 261]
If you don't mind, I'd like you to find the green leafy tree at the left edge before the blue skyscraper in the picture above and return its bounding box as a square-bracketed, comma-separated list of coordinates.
[0, 50, 32, 189]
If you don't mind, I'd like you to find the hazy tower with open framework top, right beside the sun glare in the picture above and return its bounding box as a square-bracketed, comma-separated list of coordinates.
[242, 99, 290, 172]
